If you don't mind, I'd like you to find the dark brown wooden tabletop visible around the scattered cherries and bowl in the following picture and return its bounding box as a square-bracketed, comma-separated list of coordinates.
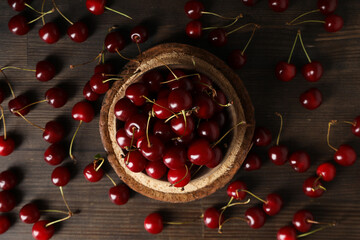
[0, 0, 360, 240]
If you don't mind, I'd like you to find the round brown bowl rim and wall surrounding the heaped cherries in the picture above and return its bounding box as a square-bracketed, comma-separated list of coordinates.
[100, 43, 255, 202]
